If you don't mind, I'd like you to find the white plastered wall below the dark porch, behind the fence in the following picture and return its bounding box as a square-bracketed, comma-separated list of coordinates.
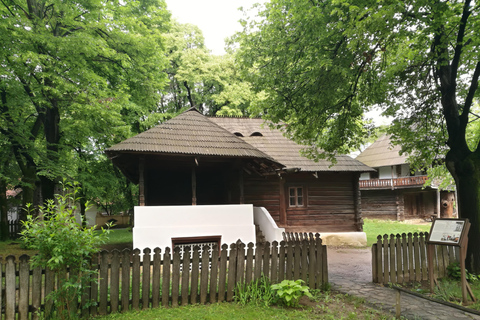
[133, 204, 255, 251]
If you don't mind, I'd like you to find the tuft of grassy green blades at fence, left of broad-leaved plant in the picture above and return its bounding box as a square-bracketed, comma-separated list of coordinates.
[234, 276, 274, 307]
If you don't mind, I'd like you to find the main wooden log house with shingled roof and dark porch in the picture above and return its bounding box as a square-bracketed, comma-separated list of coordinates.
[106, 108, 372, 242]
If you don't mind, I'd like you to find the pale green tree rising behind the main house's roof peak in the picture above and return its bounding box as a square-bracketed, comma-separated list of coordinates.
[161, 21, 264, 115]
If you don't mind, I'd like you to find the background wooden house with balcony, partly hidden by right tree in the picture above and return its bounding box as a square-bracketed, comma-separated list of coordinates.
[356, 135, 455, 220]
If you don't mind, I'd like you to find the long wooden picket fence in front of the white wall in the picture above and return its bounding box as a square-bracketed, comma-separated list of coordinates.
[0, 235, 328, 320]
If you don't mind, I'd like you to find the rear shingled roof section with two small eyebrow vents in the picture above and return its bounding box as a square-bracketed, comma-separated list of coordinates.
[209, 117, 373, 172]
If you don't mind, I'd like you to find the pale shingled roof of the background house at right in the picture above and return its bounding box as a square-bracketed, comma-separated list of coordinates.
[356, 135, 408, 168]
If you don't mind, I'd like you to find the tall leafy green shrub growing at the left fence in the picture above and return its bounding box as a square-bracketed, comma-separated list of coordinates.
[21, 183, 108, 319]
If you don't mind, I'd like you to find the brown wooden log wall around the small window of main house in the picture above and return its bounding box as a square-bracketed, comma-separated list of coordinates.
[245, 172, 360, 232]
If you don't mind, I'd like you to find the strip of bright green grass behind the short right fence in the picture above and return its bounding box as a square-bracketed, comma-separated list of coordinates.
[363, 219, 431, 247]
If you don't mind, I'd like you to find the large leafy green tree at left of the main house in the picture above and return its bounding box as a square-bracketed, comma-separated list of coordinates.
[0, 0, 169, 208]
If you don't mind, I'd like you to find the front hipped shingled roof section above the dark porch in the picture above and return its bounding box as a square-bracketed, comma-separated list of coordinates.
[106, 108, 273, 161]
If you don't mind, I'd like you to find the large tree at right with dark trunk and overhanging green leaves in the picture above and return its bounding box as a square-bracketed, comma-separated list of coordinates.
[237, 0, 480, 273]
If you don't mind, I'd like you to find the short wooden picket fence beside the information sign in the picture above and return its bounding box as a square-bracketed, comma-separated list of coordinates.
[372, 232, 459, 284]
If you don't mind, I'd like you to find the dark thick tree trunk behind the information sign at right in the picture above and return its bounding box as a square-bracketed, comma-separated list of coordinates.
[447, 151, 480, 274]
